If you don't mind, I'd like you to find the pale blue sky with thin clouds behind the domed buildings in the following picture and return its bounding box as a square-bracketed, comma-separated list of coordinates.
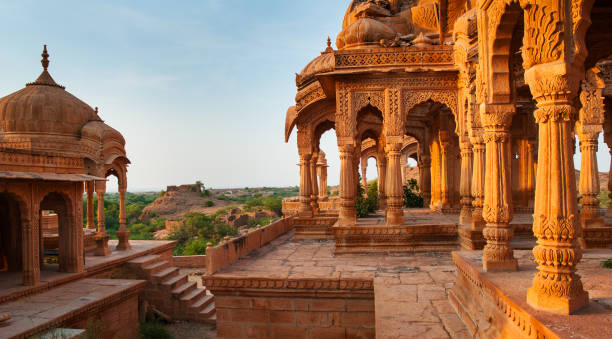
[0, 0, 610, 190]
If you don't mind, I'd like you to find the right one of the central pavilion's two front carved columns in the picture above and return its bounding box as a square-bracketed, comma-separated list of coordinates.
[386, 143, 404, 226]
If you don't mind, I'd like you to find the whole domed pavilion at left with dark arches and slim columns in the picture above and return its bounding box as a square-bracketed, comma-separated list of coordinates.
[0, 45, 130, 285]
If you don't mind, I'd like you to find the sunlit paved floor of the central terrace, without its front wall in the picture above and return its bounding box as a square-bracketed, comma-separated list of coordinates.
[203, 233, 470, 339]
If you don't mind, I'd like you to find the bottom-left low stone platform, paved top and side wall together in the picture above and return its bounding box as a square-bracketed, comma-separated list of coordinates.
[0, 279, 145, 338]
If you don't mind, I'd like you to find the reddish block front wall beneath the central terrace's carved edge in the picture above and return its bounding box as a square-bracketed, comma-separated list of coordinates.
[215, 295, 375, 339]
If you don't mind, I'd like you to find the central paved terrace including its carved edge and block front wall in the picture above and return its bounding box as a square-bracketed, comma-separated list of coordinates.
[202, 233, 469, 339]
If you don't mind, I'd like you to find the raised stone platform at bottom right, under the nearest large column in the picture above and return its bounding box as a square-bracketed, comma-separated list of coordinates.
[449, 250, 612, 338]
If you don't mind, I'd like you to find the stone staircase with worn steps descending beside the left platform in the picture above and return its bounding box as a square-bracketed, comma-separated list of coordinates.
[127, 255, 217, 324]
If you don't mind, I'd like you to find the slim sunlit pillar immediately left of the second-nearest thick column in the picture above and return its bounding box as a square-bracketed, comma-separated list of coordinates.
[470, 134, 486, 230]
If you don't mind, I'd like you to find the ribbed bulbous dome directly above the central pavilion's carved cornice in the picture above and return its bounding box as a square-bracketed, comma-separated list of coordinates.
[336, 18, 397, 49]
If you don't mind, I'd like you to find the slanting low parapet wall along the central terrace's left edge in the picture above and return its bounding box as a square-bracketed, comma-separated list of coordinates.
[205, 217, 293, 274]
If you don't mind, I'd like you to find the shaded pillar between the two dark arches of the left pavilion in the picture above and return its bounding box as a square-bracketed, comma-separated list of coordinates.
[21, 194, 40, 286]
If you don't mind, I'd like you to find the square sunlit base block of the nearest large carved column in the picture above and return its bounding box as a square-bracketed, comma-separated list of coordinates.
[527, 287, 589, 315]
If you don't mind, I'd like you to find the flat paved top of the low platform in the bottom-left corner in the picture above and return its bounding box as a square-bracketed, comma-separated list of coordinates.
[0, 279, 145, 338]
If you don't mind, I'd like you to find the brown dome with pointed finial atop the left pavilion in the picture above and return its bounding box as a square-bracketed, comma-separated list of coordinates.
[0, 45, 101, 137]
